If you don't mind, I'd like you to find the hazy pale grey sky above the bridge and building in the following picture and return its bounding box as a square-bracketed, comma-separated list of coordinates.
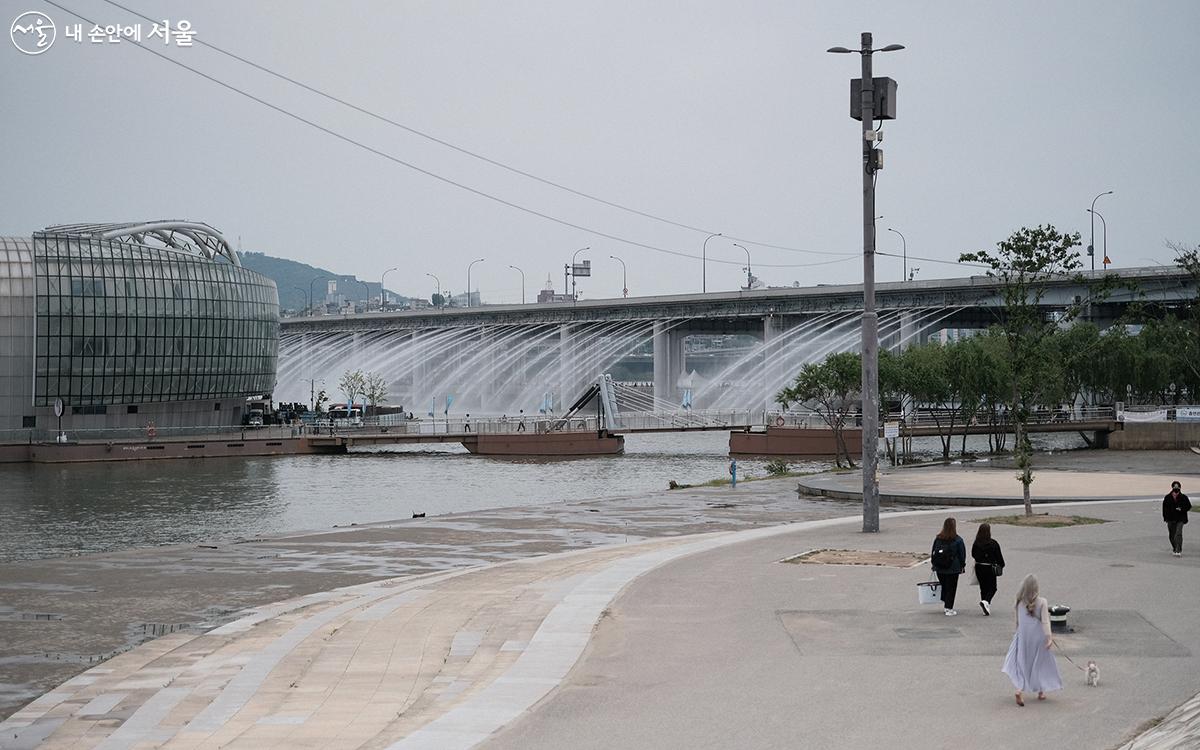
[0, 0, 1200, 301]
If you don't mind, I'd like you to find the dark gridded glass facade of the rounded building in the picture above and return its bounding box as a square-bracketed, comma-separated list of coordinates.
[34, 233, 280, 407]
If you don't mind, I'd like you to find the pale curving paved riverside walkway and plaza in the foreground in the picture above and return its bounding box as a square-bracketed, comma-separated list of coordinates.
[0, 470, 1200, 748]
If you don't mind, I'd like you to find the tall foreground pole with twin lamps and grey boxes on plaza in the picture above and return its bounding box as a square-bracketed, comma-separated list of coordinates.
[829, 31, 904, 532]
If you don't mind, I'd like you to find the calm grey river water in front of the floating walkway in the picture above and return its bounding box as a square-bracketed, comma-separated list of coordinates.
[0, 432, 1079, 562]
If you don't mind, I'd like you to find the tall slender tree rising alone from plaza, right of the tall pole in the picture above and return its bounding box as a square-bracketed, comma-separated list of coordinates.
[959, 224, 1081, 516]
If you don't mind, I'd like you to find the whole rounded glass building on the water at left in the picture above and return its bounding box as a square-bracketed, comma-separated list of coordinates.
[0, 221, 280, 431]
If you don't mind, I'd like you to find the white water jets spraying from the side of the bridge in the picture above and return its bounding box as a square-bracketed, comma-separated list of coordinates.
[275, 308, 958, 416]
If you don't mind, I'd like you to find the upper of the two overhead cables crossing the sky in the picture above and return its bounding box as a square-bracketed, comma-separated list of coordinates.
[100, 0, 858, 257]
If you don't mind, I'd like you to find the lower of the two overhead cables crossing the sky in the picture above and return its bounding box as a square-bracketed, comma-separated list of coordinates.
[46, 0, 852, 269]
